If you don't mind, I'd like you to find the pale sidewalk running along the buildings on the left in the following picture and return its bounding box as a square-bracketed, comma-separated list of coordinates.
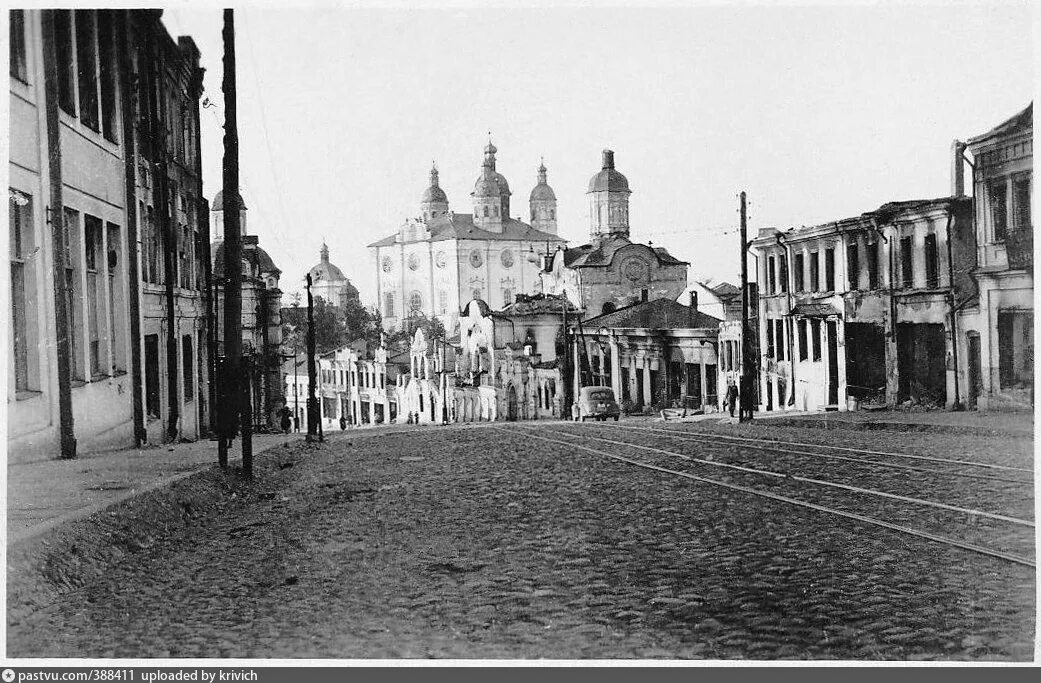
[7, 433, 295, 547]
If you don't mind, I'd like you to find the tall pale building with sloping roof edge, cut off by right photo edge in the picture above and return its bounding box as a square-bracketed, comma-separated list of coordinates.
[955, 103, 1034, 408]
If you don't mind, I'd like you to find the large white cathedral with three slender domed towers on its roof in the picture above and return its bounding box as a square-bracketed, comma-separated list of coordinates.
[369, 141, 565, 335]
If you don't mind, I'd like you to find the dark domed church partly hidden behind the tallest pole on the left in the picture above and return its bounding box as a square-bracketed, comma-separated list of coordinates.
[211, 192, 285, 429]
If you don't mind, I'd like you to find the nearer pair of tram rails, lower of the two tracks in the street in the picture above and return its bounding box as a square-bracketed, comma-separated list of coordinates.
[494, 426, 1036, 567]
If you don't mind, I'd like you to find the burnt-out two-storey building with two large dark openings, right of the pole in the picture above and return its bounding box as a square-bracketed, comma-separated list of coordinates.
[752, 197, 972, 410]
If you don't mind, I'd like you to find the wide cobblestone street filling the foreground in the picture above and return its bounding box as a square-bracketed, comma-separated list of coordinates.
[8, 421, 1035, 661]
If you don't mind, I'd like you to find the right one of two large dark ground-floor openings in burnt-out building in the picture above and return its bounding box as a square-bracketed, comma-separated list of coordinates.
[896, 323, 947, 406]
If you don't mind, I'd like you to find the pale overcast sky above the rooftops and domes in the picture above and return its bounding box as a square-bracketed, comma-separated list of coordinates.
[164, 2, 1034, 303]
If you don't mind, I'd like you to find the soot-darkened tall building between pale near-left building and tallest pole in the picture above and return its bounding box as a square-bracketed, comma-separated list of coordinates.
[127, 10, 213, 441]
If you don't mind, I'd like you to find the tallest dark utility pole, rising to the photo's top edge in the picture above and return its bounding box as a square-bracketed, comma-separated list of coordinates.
[221, 9, 253, 477]
